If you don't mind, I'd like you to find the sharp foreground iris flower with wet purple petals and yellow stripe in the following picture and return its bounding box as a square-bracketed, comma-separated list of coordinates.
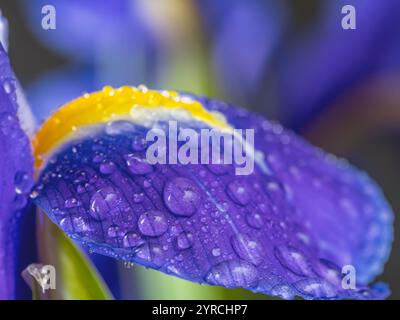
[0, 41, 393, 299]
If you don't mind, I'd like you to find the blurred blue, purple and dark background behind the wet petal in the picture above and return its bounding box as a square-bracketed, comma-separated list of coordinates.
[0, 0, 400, 299]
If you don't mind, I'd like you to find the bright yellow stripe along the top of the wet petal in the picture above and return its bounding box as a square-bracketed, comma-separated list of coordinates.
[33, 86, 229, 168]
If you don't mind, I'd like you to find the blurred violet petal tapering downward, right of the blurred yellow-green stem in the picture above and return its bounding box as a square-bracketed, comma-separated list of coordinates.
[200, 0, 285, 99]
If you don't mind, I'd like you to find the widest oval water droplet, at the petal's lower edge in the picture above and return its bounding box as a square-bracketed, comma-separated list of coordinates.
[206, 260, 258, 288]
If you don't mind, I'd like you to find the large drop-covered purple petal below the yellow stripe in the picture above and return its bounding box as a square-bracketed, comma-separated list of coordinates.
[36, 95, 392, 299]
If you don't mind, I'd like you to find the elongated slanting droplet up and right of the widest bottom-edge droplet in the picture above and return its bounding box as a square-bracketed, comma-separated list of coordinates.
[274, 245, 312, 276]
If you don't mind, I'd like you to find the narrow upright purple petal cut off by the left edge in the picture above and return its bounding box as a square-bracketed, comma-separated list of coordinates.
[0, 45, 33, 299]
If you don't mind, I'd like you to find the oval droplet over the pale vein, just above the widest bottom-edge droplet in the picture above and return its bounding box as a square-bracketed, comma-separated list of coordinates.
[231, 233, 264, 265]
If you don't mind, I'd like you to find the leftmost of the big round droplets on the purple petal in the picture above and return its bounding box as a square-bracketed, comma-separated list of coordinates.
[89, 187, 121, 220]
